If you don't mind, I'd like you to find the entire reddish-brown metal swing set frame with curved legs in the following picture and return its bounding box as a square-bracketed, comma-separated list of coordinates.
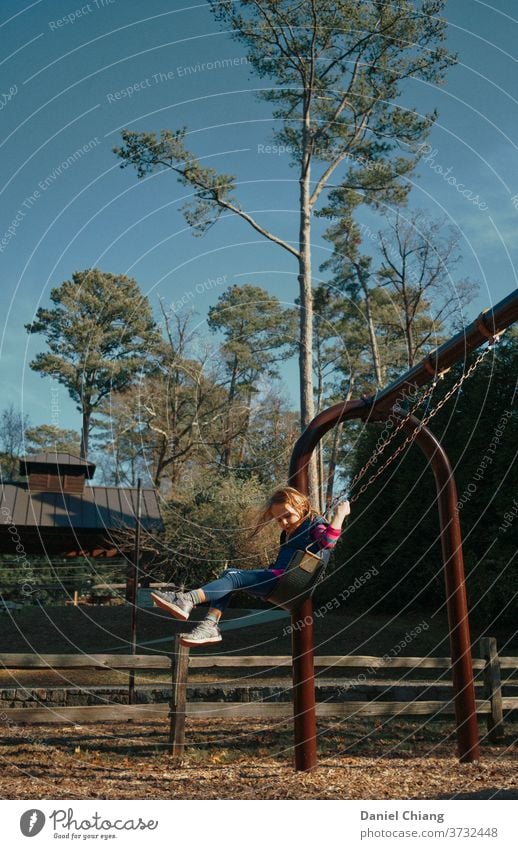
[289, 292, 518, 770]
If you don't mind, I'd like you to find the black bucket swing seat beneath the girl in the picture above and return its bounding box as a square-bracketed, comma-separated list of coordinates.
[266, 549, 331, 613]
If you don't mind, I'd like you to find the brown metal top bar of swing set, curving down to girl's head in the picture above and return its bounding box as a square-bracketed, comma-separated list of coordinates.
[289, 291, 518, 493]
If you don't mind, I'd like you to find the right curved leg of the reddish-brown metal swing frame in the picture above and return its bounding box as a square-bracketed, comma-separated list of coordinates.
[403, 416, 480, 763]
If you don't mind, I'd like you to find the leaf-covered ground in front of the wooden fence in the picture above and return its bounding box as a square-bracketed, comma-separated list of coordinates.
[0, 718, 518, 799]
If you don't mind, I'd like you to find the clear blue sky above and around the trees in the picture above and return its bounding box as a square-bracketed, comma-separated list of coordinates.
[0, 0, 518, 428]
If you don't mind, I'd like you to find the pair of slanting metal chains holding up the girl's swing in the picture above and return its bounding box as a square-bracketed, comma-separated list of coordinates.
[330, 334, 501, 509]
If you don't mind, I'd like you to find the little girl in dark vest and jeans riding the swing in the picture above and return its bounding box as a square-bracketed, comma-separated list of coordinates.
[151, 486, 351, 646]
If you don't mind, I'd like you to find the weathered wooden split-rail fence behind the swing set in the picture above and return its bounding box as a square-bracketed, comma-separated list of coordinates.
[0, 637, 518, 756]
